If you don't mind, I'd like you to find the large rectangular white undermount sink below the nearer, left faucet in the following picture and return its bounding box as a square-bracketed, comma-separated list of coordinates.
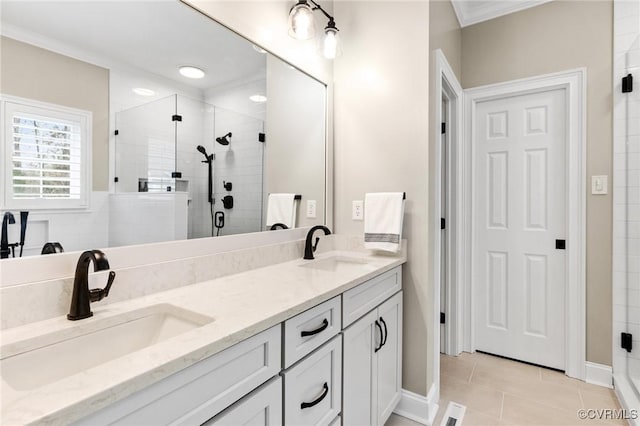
[0, 304, 213, 391]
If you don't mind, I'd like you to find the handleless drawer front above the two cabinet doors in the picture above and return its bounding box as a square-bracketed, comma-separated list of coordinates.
[342, 266, 402, 329]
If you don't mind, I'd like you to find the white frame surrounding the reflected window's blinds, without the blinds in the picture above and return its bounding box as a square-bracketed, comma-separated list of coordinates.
[0, 94, 93, 210]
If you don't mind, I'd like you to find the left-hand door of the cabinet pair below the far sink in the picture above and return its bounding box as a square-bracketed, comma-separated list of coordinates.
[342, 310, 381, 426]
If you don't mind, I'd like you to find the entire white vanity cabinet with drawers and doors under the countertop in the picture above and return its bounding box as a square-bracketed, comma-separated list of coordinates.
[70, 266, 402, 426]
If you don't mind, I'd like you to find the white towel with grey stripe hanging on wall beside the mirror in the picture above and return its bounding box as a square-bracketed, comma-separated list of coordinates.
[364, 192, 404, 253]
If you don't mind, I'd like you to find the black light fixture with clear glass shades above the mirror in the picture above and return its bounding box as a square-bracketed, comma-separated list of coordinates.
[289, 0, 340, 59]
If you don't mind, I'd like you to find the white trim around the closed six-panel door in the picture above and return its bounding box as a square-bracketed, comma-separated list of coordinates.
[458, 68, 587, 380]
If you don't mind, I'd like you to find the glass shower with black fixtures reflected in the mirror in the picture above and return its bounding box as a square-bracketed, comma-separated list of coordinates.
[115, 94, 264, 243]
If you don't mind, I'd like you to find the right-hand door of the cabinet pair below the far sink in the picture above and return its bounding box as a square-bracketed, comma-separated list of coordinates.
[372, 292, 402, 425]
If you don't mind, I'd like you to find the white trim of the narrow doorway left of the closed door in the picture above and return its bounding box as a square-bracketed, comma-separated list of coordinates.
[429, 49, 466, 401]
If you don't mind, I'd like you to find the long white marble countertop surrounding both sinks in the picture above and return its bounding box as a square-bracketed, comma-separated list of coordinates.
[0, 251, 406, 425]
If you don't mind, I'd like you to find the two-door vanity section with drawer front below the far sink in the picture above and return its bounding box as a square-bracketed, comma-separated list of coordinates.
[342, 268, 402, 426]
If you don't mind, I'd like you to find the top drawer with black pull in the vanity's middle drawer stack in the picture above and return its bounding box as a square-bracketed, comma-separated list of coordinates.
[283, 296, 342, 368]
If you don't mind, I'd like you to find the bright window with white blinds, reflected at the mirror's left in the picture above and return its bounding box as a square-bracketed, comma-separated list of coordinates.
[3, 100, 90, 208]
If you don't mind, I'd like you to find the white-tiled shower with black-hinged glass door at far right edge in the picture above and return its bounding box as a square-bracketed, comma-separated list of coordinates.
[613, 0, 640, 414]
